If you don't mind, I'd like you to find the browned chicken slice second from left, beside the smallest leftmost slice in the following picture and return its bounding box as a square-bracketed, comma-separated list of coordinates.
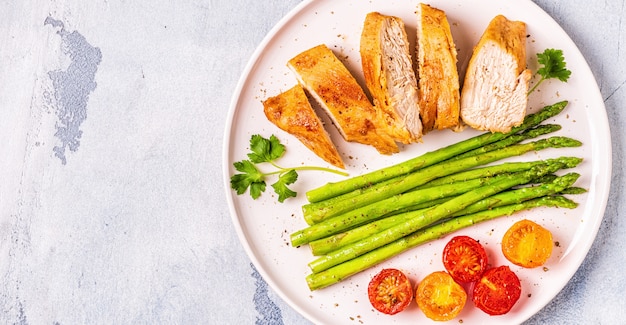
[287, 44, 399, 154]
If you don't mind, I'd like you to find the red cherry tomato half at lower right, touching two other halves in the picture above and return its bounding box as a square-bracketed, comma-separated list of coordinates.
[472, 265, 522, 315]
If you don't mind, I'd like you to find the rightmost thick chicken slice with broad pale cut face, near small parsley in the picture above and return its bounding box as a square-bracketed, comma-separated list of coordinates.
[461, 15, 532, 132]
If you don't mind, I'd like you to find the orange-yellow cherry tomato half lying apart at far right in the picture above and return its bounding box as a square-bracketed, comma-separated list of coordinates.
[502, 219, 554, 268]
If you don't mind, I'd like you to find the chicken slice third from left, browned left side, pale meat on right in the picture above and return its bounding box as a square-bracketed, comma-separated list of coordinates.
[360, 12, 422, 144]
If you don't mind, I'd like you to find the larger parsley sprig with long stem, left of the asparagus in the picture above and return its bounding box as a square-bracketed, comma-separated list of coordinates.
[230, 134, 348, 203]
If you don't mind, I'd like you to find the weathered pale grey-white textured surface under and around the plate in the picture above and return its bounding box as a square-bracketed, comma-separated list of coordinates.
[0, 0, 626, 324]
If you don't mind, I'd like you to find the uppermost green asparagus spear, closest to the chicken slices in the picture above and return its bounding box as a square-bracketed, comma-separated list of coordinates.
[306, 101, 568, 202]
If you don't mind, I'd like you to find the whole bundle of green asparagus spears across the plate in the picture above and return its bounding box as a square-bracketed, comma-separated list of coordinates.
[291, 101, 584, 290]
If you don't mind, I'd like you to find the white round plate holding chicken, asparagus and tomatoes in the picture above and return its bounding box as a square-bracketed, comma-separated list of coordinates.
[223, 0, 611, 324]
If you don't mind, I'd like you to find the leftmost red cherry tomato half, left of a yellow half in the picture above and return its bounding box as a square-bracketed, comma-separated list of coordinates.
[367, 269, 413, 315]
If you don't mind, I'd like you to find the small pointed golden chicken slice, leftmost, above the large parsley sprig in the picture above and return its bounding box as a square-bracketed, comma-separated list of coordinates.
[263, 85, 345, 168]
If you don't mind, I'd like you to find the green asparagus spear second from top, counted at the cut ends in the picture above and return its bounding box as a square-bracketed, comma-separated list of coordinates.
[292, 137, 581, 225]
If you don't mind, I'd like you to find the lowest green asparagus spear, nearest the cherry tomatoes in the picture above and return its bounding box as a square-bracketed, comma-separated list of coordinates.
[306, 196, 577, 291]
